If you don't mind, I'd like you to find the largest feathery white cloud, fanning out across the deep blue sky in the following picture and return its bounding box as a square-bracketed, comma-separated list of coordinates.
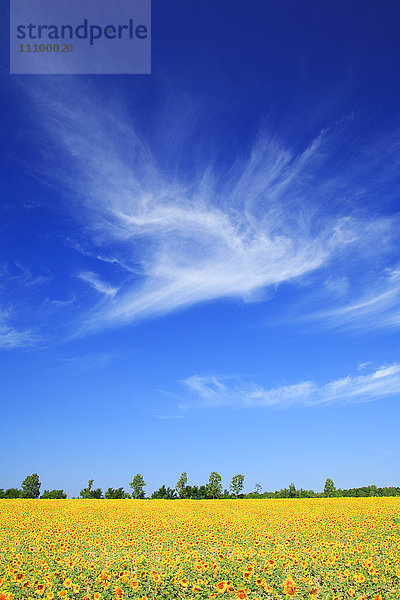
[21, 82, 397, 332]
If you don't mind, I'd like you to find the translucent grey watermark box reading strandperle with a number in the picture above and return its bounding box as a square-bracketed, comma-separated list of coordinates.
[10, 0, 151, 75]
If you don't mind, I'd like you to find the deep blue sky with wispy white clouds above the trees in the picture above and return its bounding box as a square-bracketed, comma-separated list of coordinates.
[0, 0, 400, 495]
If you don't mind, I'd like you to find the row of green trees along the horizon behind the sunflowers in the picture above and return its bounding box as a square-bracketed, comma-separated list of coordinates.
[0, 471, 400, 500]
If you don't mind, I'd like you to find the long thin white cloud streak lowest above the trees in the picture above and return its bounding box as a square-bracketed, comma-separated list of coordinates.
[182, 363, 400, 408]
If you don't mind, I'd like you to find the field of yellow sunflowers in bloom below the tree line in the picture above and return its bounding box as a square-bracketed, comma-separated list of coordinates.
[0, 498, 400, 600]
